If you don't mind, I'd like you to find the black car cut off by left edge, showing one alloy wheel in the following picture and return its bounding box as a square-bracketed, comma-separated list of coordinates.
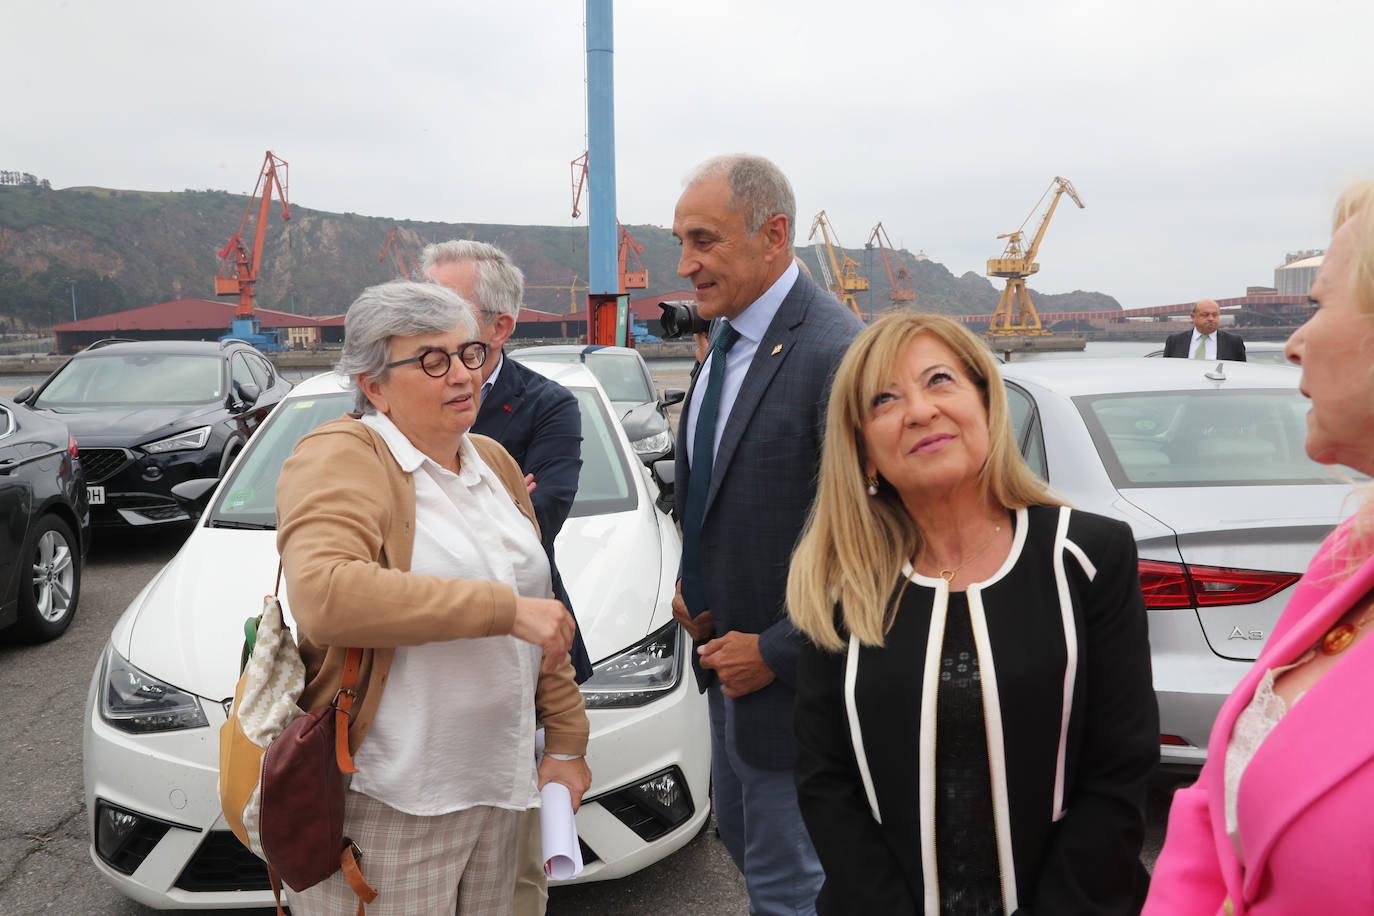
[0, 398, 91, 641]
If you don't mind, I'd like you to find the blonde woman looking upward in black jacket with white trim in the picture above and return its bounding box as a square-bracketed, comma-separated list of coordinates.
[787, 312, 1158, 916]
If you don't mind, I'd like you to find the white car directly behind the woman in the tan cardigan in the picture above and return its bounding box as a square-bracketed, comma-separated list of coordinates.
[82, 360, 710, 909]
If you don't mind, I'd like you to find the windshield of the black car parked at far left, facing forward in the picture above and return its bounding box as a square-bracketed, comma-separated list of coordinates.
[33, 353, 224, 408]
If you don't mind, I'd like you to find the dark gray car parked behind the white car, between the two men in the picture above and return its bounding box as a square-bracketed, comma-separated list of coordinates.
[508, 345, 687, 466]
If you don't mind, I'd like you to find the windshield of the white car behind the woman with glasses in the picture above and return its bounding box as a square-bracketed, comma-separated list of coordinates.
[207, 387, 639, 527]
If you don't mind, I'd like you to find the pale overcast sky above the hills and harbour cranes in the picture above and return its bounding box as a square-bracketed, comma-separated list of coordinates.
[0, 0, 1374, 308]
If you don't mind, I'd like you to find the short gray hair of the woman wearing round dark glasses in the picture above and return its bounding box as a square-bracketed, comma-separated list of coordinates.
[334, 280, 477, 413]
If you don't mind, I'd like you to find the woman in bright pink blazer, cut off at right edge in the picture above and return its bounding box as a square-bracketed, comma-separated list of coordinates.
[1145, 181, 1374, 916]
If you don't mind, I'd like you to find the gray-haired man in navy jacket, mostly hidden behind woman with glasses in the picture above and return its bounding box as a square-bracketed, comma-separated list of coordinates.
[422, 240, 592, 916]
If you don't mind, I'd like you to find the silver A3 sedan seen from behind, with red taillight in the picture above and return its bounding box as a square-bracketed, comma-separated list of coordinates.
[1002, 358, 1363, 769]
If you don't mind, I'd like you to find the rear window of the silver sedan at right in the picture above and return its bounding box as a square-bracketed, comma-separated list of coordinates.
[1074, 389, 1363, 489]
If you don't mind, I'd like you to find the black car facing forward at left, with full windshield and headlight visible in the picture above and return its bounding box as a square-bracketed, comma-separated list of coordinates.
[15, 341, 291, 527]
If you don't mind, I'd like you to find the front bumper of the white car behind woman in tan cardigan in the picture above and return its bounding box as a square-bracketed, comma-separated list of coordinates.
[82, 648, 710, 909]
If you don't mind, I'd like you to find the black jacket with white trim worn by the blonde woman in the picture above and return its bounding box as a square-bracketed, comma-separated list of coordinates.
[796, 505, 1160, 916]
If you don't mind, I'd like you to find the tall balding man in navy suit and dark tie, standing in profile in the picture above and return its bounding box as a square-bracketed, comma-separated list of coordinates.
[673, 155, 863, 915]
